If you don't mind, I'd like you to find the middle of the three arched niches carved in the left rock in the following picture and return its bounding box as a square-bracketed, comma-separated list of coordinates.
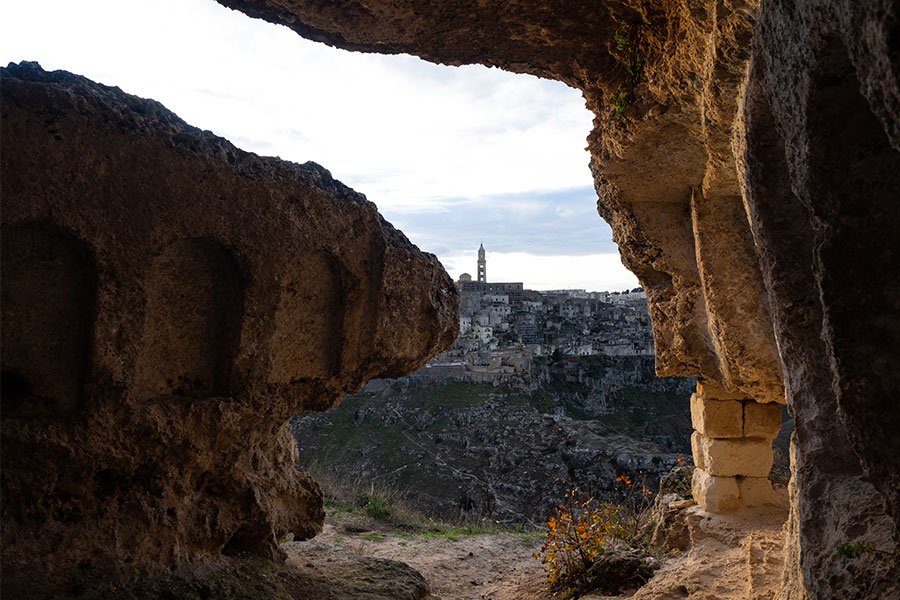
[135, 238, 243, 399]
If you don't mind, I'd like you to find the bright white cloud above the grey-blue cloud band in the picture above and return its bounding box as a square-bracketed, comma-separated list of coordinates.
[0, 0, 591, 206]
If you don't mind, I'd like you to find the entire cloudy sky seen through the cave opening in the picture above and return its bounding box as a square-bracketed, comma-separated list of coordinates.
[0, 0, 638, 290]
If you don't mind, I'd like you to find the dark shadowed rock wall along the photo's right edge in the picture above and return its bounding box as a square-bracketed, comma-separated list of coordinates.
[743, 2, 900, 598]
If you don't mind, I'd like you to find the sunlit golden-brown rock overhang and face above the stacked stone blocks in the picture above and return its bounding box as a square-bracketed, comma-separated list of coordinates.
[220, 0, 785, 403]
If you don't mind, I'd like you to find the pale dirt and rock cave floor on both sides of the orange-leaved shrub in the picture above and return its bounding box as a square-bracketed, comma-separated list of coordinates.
[284, 490, 787, 600]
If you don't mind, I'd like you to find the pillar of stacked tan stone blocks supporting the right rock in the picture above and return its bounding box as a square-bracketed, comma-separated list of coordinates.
[691, 382, 781, 512]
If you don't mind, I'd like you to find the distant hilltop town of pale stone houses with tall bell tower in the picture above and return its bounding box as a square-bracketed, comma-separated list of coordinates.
[427, 244, 653, 379]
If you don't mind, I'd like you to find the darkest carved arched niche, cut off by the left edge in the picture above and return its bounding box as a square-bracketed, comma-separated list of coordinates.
[0, 223, 96, 417]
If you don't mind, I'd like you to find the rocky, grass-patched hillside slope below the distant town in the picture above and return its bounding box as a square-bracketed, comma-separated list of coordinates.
[291, 356, 692, 525]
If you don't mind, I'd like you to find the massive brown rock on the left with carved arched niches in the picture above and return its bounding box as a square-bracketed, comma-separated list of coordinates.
[2, 63, 457, 595]
